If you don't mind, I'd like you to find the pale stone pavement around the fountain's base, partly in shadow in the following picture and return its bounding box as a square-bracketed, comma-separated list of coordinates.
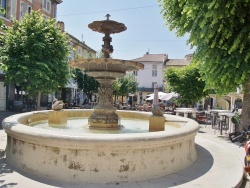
[0, 111, 250, 188]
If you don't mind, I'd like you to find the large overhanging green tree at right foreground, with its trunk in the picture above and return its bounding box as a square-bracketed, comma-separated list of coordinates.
[158, 0, 250, 127]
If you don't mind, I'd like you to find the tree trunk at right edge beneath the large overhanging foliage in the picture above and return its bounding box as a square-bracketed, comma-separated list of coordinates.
[240, 80, 250, 130]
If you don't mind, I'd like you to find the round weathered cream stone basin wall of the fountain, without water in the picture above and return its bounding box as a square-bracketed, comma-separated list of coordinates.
[3, 109, 199, 183]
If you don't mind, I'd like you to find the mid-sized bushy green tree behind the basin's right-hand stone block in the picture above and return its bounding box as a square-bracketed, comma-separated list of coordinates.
[165, 64, 210, 106]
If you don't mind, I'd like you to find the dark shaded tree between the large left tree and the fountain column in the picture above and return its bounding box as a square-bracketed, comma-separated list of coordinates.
[74, 69, 100, 98]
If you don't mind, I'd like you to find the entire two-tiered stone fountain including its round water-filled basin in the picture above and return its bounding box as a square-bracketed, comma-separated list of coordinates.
[0, 16, 199, 183]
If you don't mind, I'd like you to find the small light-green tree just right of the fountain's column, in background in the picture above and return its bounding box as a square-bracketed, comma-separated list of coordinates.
[112, 75, 138, 102]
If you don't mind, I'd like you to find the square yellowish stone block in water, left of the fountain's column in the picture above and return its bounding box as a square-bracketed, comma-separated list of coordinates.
[48, 110, 68, 127]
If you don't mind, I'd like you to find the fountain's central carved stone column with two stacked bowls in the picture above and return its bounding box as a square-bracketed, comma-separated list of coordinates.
[69, 14, 144, 129]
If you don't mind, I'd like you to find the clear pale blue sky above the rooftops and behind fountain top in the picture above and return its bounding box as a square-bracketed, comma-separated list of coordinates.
[57, 0, 194, 60]
